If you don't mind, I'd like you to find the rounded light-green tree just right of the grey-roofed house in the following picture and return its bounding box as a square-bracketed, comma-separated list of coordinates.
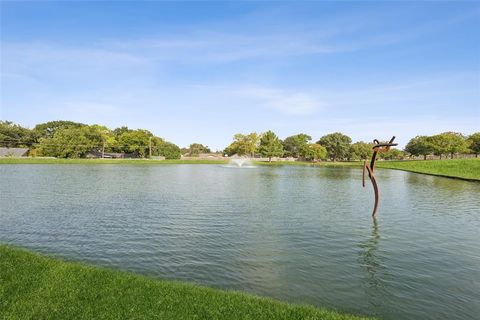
[38, 126, 103, 158]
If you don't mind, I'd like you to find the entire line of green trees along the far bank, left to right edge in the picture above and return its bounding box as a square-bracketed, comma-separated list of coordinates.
[0, 121, 480, 161]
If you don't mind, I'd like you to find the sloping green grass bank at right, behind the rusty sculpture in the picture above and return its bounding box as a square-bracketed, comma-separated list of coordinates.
[377, 158, 480, 181]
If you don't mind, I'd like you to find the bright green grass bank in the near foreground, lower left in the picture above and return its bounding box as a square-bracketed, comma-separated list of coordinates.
[0, 245, 372, 320]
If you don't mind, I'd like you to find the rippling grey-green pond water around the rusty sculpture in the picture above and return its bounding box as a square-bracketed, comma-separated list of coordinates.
[0, 165, 480, 319]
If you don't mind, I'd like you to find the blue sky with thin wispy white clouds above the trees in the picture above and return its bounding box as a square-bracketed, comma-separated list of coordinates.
[0, 1, 480, 149]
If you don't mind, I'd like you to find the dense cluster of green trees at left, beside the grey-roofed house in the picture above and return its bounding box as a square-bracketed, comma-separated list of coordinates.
[0, 121, 181, 159]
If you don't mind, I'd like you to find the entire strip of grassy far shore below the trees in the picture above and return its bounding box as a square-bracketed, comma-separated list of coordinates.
[0, 157, 480, 181]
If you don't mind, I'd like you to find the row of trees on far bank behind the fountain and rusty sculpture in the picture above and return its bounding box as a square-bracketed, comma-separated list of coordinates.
[224, 131, 480, 161]
